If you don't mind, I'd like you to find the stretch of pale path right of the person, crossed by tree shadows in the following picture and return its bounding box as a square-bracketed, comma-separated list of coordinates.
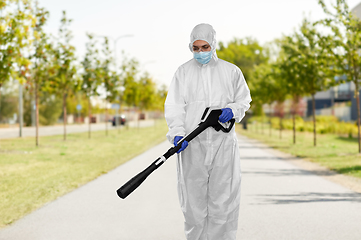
[237, 137, 361, 240]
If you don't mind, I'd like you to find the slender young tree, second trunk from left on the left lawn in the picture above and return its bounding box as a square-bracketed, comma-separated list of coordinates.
[52, 11, 77, 141]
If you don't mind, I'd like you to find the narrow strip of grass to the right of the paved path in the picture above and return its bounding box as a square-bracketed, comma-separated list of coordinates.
[237, 124, 361, 178]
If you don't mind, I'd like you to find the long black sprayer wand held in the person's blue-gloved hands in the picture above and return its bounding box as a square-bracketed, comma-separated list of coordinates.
[117, 108, 235, 199]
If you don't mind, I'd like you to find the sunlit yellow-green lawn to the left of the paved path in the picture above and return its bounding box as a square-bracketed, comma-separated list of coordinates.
[0, 121, 168, 228]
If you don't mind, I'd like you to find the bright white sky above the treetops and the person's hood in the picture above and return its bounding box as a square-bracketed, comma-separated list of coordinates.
[39, 0, 361, 85]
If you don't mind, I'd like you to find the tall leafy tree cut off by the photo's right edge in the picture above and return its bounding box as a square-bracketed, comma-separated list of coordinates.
[316, 0, 361, 153]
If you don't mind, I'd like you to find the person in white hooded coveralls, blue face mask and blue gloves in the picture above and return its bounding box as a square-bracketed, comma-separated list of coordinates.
[165, 24, 251, 240]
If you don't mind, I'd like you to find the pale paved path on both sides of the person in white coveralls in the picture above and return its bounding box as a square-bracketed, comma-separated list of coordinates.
[0, 136, 361, 240]
